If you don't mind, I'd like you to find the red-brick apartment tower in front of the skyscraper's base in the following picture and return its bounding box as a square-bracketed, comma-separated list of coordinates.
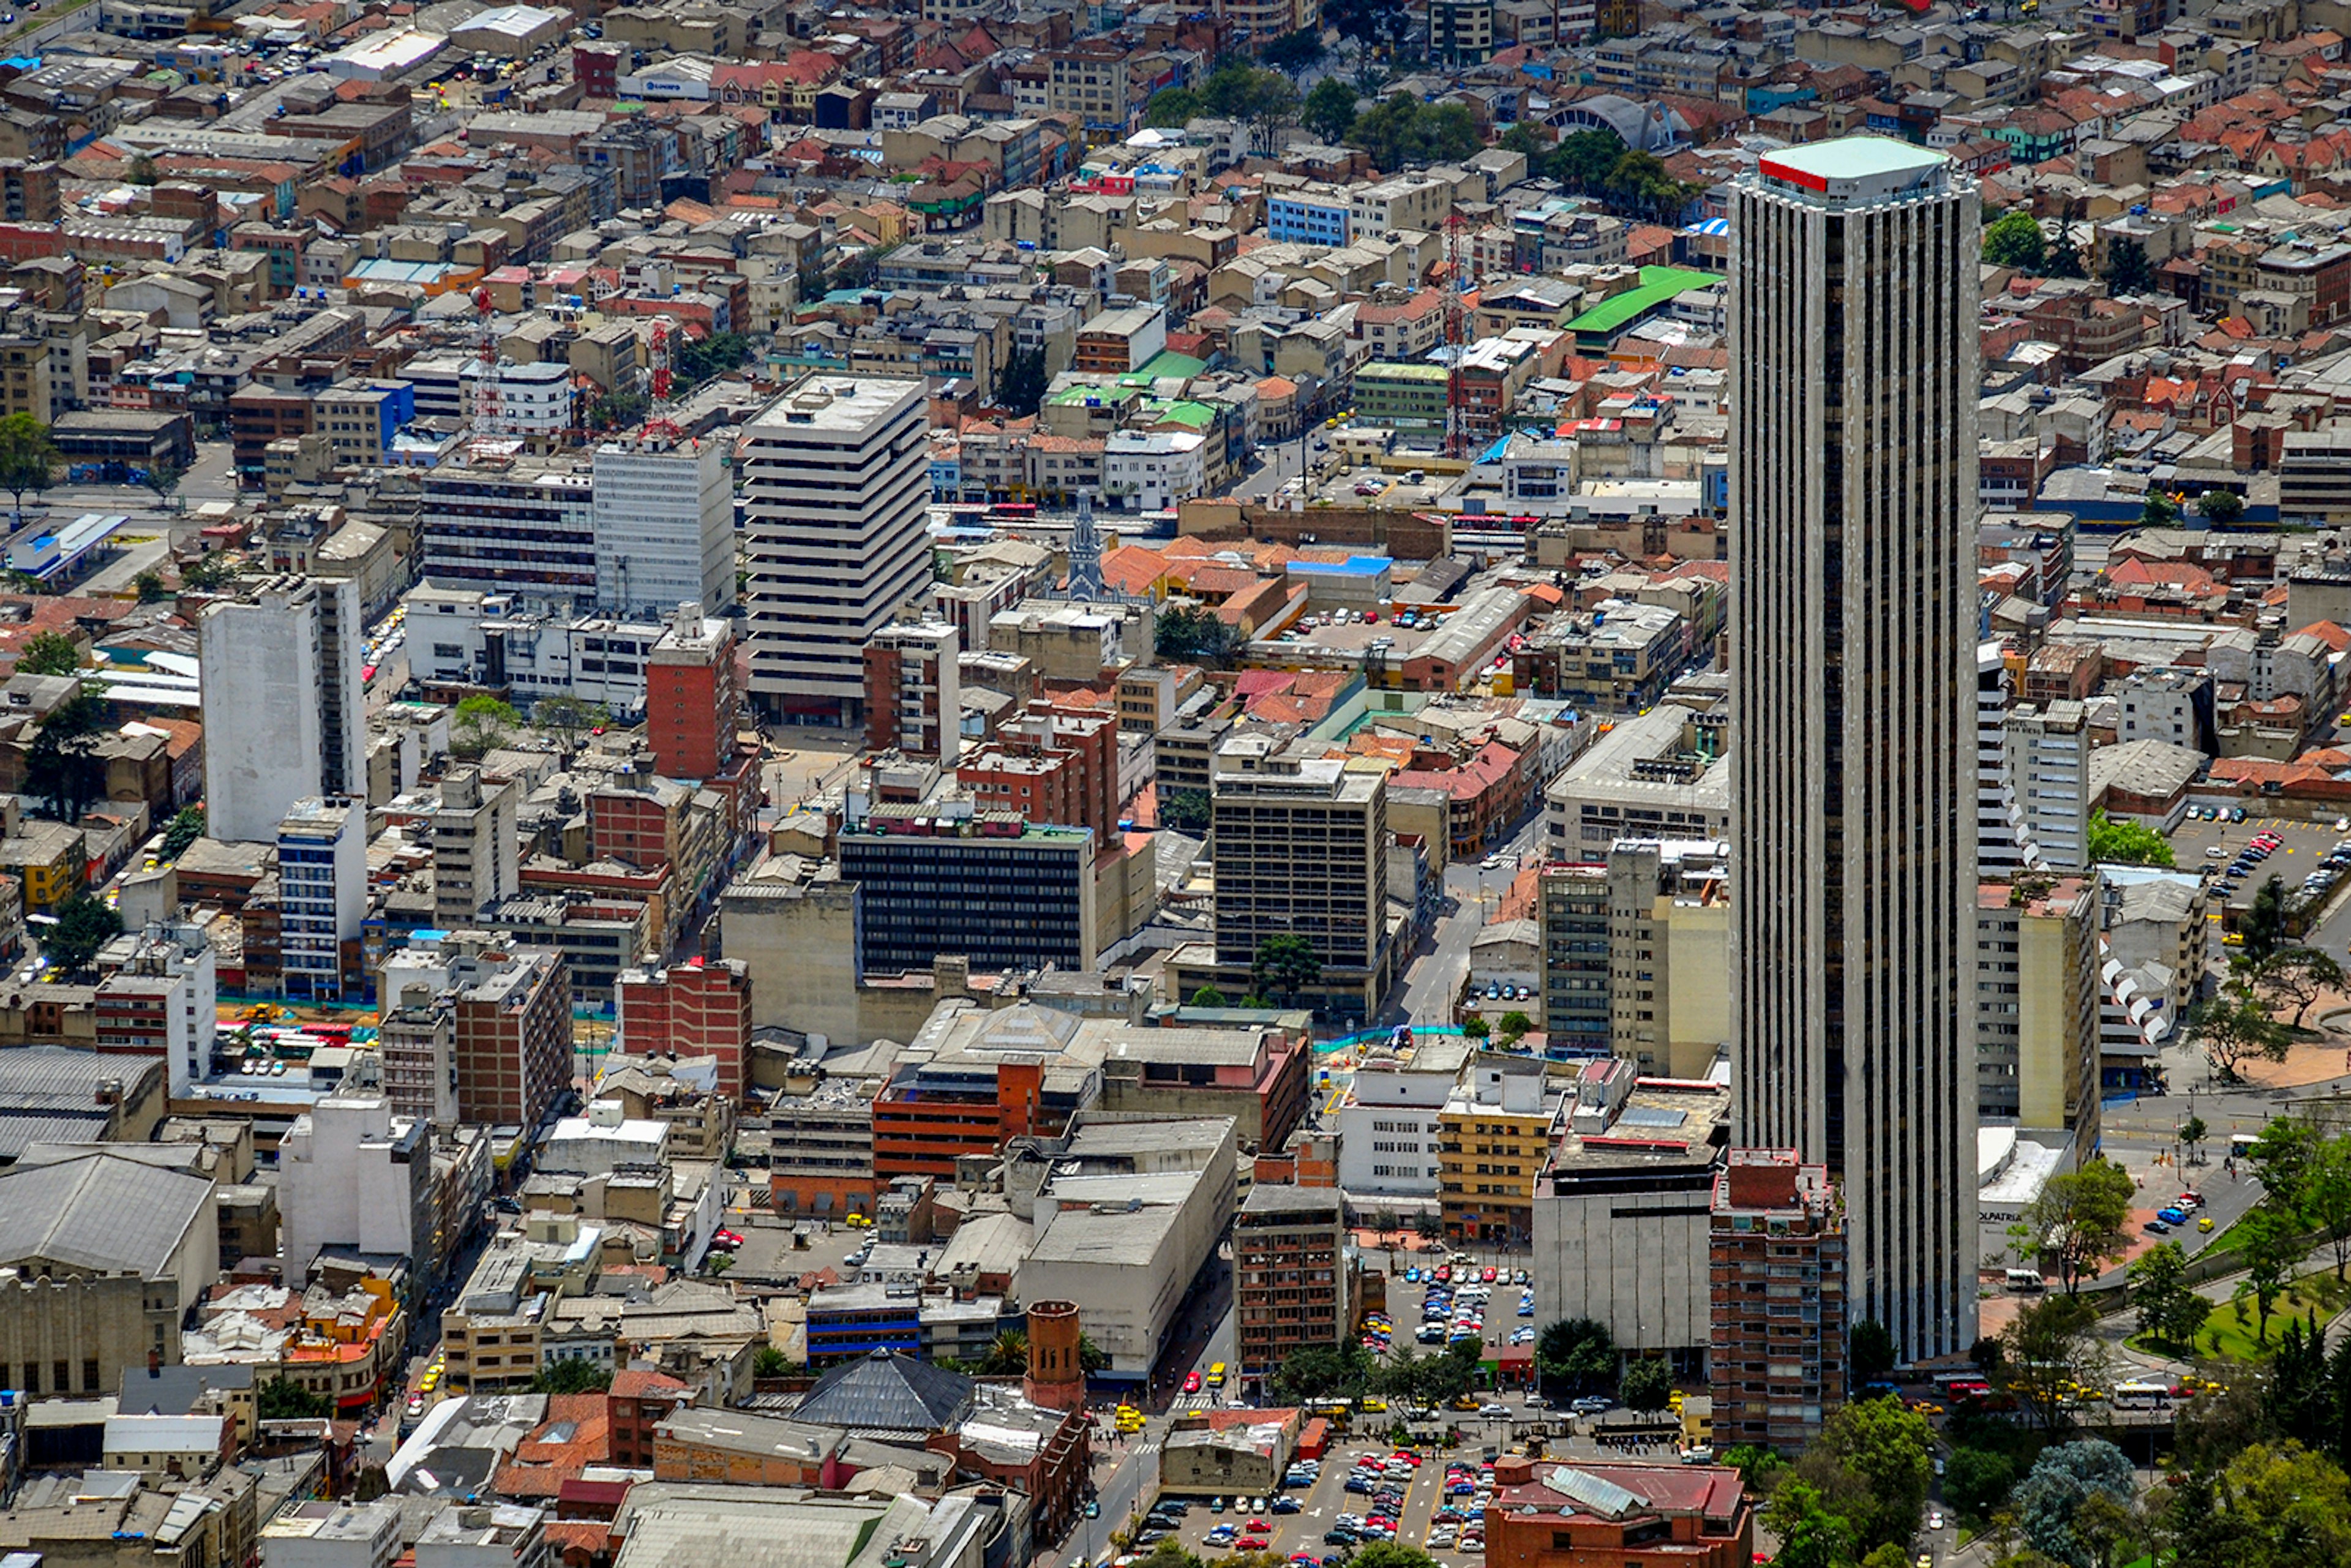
[1707, 1150, 1848, 1453]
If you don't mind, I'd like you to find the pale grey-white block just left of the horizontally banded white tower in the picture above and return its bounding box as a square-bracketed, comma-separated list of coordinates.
[595, 430, 733, 616]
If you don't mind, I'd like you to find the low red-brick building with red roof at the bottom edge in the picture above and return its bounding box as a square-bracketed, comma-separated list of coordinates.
[1486, 1453, 1756, 1568]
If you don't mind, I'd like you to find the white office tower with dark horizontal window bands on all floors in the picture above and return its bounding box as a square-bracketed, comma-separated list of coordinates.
[743, 376, 931, 724]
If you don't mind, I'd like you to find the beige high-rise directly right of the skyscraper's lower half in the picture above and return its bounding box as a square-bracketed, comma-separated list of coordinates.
[1975, 877, 2099, 1133]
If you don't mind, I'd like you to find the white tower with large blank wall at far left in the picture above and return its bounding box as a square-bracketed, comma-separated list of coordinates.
[195, 576, 367, 844]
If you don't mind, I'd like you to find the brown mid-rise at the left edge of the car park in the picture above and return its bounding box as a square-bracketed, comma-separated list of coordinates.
[1232, 1182, 1357, 1387]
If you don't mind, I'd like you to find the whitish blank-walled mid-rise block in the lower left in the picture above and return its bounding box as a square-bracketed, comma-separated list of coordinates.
[277, 1095, 442, 1291]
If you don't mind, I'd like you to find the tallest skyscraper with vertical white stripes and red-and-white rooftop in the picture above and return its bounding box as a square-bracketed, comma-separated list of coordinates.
[1730, 137, 1979, 1361]
